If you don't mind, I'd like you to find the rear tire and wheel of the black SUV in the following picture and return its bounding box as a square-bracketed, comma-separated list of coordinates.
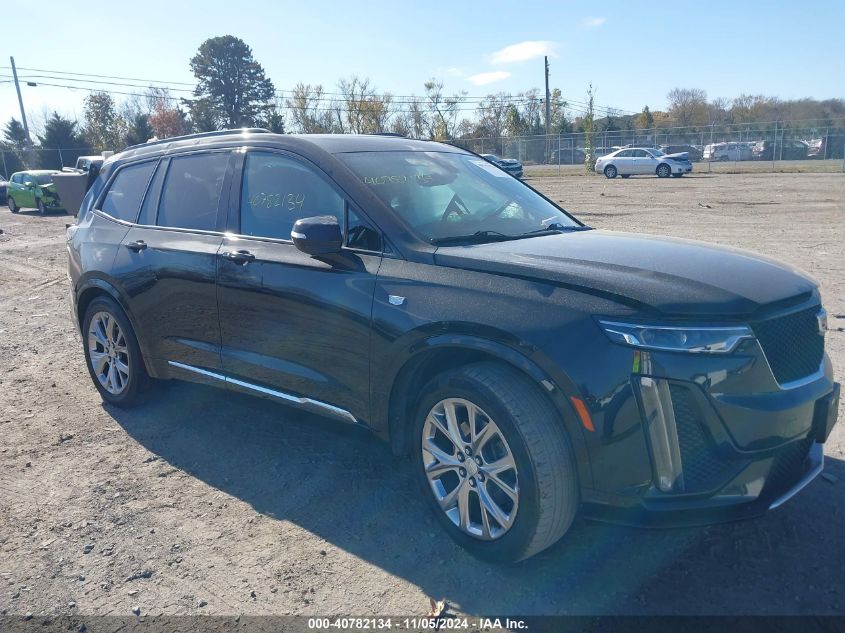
[82, 297, 149, 407]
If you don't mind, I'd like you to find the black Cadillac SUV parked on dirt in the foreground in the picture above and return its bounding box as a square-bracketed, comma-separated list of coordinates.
[67, 130, 839, 560]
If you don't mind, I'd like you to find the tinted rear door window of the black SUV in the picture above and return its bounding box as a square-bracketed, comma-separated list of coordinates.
[156, 152, 229, 231]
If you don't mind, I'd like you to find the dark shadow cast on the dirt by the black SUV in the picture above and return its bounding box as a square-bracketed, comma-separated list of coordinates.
[108, 383, 845, 615]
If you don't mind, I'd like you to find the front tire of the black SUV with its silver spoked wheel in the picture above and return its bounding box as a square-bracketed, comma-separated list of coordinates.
[412, 362, 579, 562]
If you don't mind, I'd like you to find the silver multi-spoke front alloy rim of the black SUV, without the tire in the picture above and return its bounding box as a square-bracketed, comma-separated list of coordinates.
[422, 398, 519, 540]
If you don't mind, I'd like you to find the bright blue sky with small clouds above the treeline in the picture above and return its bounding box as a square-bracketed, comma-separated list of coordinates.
[0, 0, 845, 131]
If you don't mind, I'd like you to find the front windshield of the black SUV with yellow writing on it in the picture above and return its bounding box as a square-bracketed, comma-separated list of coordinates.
[337, 152, 580, 243]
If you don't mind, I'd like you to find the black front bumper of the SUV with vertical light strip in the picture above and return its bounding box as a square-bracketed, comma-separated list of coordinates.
[576, 304, 840, 526]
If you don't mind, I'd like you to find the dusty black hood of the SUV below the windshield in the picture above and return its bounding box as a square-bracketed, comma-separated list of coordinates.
[435, 230, 816, 318]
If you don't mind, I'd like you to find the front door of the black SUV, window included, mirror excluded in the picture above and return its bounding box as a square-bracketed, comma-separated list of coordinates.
[217, 150, 382, 420]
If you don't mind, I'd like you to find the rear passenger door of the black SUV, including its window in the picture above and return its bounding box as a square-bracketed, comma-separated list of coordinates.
[109, 151, 233, 369]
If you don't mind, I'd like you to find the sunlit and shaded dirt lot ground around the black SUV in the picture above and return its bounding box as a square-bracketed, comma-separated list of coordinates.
[0, 174, 845, 615]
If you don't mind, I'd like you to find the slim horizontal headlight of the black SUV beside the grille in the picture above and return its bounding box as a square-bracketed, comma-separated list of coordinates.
[599, 320, 754, 354]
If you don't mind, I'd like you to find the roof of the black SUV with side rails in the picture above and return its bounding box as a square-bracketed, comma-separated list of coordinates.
[115, 129, 463, 163]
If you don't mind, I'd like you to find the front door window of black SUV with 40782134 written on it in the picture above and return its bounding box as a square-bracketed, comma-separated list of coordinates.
[240, 152, 343, 240]
